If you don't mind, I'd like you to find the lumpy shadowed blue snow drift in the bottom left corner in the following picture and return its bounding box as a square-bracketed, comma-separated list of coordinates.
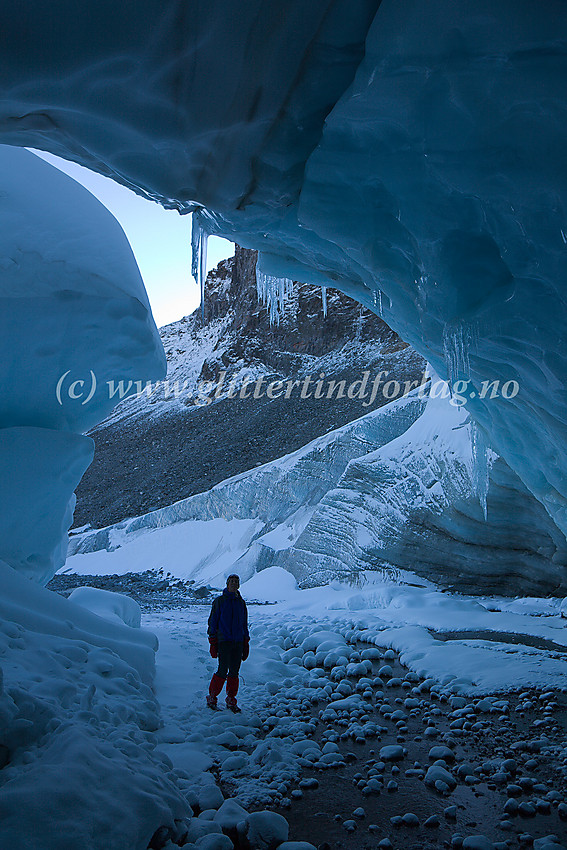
[0, 562, 190, 850]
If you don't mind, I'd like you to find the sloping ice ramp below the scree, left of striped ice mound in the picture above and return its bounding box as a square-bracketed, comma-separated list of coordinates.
[68, 391, 425, 584]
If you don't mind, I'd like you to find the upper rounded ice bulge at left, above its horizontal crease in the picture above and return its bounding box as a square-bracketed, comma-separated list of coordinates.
[0, 145, 165, 433]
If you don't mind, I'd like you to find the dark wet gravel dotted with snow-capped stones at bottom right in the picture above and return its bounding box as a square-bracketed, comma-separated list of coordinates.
[278, 645, 567, 850]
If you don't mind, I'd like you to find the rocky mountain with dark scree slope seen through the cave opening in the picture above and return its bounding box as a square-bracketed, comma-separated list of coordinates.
[75, 246, 424, 527]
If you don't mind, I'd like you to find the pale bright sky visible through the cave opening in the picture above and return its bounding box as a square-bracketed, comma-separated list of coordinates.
[30, 151, 234, 327]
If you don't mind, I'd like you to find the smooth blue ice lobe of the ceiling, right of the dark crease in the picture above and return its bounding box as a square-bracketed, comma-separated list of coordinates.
[299, 0, 567, 544]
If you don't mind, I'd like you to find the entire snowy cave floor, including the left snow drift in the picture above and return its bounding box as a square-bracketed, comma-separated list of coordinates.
[4, 552, 567, 850]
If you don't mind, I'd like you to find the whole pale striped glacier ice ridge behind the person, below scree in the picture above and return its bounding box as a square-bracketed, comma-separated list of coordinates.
[66, 391, 567, 595]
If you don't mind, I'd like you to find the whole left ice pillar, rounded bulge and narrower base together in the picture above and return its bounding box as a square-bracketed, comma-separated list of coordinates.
[0, 146, 165, 582]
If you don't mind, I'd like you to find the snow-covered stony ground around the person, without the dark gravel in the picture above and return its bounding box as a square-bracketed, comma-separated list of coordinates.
[144, 568, 567, 850]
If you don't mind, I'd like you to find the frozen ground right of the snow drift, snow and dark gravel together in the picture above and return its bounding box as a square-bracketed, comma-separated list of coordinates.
[38, 568, 567, 850]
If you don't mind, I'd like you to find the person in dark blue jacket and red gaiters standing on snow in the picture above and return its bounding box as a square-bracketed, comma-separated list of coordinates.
[207, 573, 250, 712]
